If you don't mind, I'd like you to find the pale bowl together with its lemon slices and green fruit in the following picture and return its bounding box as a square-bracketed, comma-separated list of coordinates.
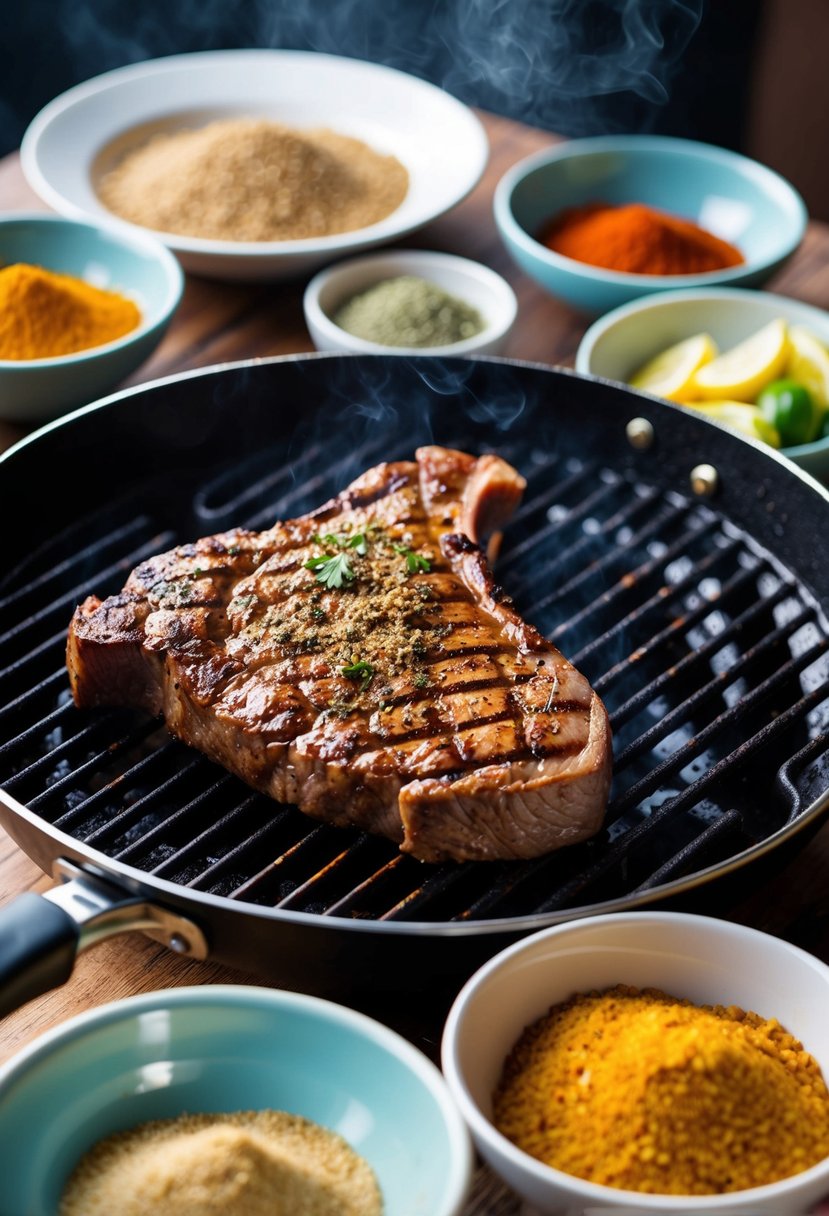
[576, 288, 829, 479]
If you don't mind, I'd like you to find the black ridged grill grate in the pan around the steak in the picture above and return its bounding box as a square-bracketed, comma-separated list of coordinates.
[0, 413, 829, 923]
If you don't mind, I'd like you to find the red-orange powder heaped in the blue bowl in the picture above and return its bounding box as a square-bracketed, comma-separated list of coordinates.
[540, 203, 745, 275]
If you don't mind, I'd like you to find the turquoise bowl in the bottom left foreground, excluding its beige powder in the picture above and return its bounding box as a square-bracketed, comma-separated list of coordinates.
[0, 985, 472, 1216]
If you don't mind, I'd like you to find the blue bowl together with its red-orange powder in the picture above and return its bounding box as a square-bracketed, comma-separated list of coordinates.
[495, 135, 807, 315]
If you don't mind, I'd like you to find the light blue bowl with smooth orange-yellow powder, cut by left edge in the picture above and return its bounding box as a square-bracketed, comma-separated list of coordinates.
[0, 214, 184, 422]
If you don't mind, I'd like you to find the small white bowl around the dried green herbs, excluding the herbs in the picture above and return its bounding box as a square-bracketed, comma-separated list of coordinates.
[303, 249, 518, 355]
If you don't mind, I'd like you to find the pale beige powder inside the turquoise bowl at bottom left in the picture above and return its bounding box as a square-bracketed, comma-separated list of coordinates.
[58, 1110, 383, 1216]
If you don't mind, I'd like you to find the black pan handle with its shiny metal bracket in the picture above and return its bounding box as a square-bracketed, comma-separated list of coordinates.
[0, 858, 208, 1018]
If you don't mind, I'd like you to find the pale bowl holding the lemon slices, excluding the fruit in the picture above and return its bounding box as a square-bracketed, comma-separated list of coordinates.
[576, 288, 829, 479]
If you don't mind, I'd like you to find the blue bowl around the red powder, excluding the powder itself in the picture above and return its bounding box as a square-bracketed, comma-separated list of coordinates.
[495, 135, 807, 315]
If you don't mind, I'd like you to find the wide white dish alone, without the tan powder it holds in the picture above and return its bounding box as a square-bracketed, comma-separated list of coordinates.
[21, 50, 489, 280]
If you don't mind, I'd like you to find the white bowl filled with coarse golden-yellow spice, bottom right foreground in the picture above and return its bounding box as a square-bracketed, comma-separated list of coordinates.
[442, 912, 829, 1216]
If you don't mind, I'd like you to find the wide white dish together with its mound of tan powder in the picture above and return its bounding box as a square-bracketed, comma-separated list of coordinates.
[22, 50, 489, 280]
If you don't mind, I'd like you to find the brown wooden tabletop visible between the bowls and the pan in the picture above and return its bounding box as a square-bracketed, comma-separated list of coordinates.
[0, 107, 829, 1063]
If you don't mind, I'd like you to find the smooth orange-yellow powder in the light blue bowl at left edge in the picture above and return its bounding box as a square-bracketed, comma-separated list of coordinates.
[0, 263, 141, 360]
